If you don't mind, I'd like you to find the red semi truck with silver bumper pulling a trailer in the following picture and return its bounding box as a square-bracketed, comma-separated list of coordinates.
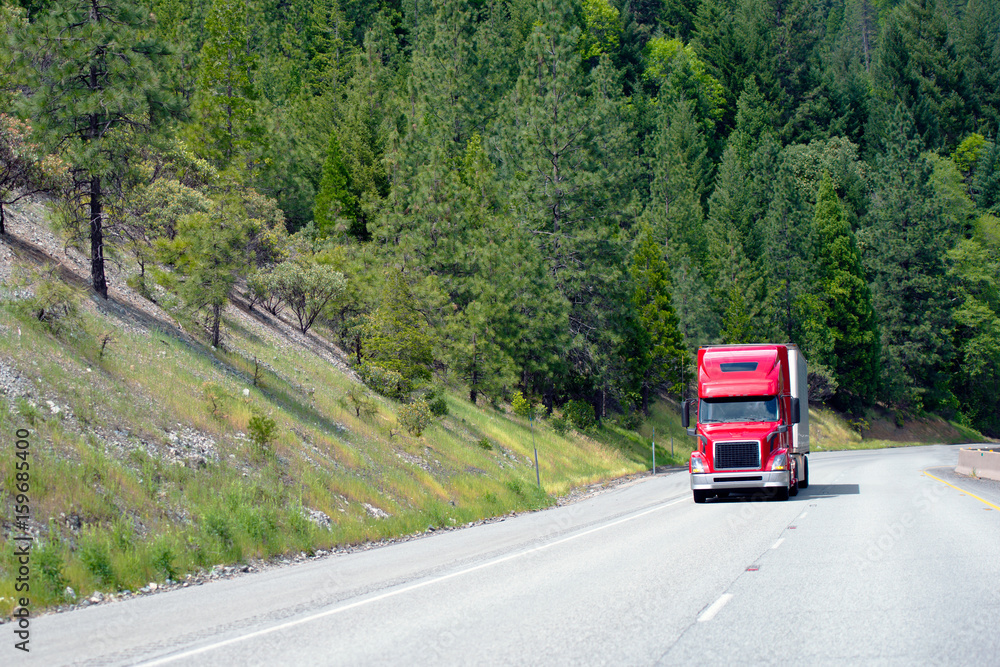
[681, 344, 809, 503]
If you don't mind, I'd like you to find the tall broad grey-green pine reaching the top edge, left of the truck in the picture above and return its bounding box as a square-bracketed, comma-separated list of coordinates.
[500, 4, 627, 408]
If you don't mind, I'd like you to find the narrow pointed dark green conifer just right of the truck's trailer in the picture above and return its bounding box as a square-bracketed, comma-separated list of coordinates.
[814, 175, 879, 411]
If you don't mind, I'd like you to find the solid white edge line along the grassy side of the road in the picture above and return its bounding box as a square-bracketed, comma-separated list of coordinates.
[138, 494, 688, 667]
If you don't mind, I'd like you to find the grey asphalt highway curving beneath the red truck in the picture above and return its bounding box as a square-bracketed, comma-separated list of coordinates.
[17, 446, 1000, 667]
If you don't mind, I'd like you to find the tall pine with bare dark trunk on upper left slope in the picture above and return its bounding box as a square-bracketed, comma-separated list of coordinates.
[16, 0, 178, 298]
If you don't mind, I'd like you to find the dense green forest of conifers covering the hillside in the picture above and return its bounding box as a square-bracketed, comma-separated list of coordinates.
[0, 0, 1000, 435]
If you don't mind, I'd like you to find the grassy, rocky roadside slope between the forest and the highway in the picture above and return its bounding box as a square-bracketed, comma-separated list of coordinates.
[0, 247, 689, 614]
